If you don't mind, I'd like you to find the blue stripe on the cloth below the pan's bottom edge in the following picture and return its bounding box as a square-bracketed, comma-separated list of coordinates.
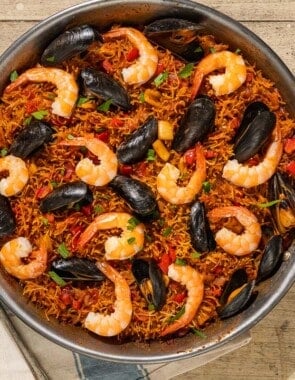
[74, 354, 149, 380]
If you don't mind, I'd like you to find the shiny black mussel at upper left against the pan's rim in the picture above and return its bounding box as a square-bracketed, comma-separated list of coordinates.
[41, 25, 102, 66]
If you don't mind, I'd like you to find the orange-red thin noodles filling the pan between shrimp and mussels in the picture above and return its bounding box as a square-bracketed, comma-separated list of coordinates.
[0, 27, 294, 340]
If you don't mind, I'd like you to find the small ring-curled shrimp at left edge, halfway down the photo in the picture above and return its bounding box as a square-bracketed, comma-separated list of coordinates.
[0, 155, 29, 197]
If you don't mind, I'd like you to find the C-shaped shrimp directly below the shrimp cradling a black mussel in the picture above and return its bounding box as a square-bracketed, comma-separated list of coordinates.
[208, 206, 261, 256]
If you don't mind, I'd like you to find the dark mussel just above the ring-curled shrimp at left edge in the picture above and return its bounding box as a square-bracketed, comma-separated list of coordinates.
[9, 120, 55, 158]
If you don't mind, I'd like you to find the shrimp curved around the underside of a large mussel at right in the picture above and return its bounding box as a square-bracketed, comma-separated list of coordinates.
[222, 127, 283, 188]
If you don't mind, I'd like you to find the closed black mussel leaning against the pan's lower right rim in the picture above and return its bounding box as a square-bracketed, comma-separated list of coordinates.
[256, 235, 284, 283]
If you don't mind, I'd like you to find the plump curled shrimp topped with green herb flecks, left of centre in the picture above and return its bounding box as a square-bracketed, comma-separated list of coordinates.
[77, 212, 144, 260]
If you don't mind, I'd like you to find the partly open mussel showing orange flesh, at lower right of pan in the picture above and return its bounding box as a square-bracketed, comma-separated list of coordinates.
[218, 269, 255, 319]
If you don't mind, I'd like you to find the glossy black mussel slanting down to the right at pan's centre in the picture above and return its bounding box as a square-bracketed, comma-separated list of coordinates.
[109, 175, 158, 220]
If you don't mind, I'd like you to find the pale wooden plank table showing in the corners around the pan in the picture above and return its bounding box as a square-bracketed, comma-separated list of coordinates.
[0, 0, 295, 380]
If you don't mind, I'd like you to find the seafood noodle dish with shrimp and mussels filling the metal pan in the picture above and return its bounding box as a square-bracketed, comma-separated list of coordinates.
[0, 18, 295, 342]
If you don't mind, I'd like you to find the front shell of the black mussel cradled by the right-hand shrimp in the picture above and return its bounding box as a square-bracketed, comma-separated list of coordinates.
[234, 111, 276, 163]
